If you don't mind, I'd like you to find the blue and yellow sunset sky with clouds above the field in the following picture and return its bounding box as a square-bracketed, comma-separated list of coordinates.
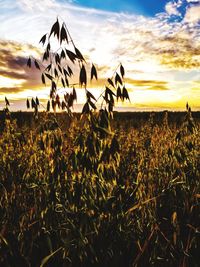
[0, 0, 200, 111]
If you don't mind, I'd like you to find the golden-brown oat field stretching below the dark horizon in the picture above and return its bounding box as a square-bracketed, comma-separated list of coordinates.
[0, 110, 200, 267]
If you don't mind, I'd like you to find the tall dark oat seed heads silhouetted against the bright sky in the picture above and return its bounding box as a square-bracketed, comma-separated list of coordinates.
[27, 18, 129, 117]
